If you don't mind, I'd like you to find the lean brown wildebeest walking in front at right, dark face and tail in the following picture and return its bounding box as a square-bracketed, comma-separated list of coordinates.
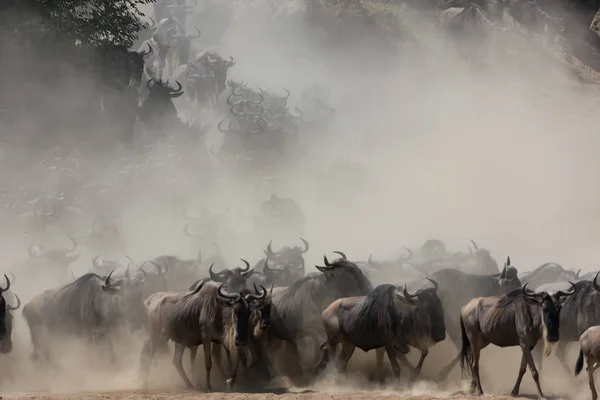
[460, 284, 576, 398]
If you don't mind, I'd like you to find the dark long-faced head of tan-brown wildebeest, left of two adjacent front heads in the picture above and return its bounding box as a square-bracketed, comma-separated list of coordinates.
[217, 283, 256, 347]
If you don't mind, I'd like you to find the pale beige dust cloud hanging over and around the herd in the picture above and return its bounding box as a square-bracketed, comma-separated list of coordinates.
[0, 0, 600, 398]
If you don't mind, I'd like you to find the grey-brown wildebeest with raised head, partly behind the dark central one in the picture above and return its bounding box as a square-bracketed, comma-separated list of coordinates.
[267, 253, 373, 382]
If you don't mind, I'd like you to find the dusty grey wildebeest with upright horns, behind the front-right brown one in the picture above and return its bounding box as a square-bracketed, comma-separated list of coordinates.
[430, 257, 521, 379]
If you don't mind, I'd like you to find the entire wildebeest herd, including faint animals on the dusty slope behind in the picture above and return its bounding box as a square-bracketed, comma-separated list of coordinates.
[0, 0, 600, 400]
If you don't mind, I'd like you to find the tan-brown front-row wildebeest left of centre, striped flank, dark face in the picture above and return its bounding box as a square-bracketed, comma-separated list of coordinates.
[140, 280, 267, 392]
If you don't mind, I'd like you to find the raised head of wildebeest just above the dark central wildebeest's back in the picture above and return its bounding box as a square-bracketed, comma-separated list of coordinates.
[316, 251, 373, 297]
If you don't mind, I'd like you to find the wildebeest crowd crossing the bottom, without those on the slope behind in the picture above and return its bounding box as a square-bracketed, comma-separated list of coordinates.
[0, 239, 600, 398]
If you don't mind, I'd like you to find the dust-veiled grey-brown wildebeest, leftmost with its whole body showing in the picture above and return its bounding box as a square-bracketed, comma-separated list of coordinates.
[23, 273, 132, 360]
